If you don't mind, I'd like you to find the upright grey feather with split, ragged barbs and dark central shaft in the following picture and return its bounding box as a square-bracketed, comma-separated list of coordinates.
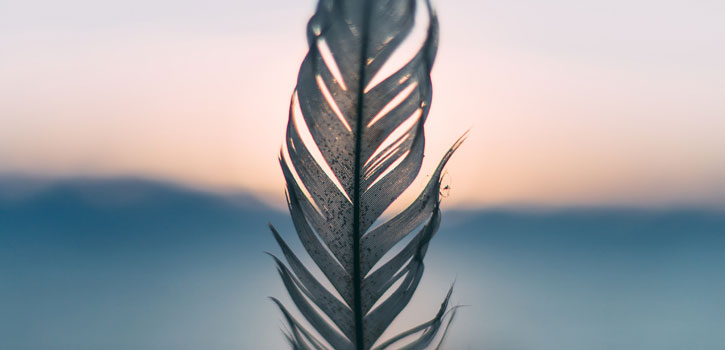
[270, 0, 463, 350]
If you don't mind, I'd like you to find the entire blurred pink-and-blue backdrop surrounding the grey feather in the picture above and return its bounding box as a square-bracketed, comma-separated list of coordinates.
[0, 0, 725, 350]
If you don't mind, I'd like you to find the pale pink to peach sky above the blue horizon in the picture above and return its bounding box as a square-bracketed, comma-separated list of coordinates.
[0, 0, 725, 206]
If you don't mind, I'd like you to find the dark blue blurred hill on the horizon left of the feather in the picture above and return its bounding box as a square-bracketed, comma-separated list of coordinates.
[0, 177, 285, 250]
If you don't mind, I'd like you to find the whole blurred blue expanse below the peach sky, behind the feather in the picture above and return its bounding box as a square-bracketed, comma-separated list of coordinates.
[0, 179, 725, 350]
